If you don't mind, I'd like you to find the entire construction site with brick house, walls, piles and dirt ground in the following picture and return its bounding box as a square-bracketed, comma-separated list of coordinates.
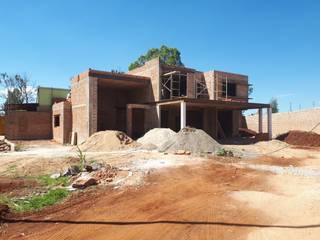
[0, 58, 320, 240]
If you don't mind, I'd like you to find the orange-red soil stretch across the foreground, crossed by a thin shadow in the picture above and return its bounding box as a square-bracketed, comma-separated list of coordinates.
[0, 163, 271, 240]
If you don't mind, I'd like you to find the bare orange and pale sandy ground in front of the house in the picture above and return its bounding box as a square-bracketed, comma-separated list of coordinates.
[0, 141, 320, 239]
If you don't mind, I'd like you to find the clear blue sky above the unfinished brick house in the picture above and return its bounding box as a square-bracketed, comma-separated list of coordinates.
[0, 0, 320, 111]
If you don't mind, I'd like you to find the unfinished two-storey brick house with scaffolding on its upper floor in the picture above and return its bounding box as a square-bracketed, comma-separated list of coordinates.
[52, 58, 272, 143]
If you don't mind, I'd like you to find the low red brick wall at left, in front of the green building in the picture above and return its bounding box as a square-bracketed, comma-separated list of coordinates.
[5, 111, 52, 140]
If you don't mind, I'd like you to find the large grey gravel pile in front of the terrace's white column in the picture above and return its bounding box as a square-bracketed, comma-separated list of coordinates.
[159, 128, 221, 153]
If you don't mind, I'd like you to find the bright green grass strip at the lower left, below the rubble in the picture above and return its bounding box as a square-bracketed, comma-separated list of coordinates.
[0, 189, 69, 212]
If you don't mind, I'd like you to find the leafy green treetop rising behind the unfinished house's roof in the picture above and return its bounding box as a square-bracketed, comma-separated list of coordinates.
[129, 45, 184, 70]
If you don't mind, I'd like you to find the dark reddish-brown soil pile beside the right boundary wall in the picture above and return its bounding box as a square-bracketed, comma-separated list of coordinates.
[276, 131, 320, 147]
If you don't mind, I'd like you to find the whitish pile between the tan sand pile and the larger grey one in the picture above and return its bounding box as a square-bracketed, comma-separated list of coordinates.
[137, 128, 176, 147]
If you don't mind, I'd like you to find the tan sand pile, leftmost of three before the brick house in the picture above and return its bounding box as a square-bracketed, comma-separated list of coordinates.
[80, 130, 139, 152]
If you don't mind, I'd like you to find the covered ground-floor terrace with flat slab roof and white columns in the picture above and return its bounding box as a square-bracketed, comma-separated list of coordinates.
[126, 98, 272, 139]
